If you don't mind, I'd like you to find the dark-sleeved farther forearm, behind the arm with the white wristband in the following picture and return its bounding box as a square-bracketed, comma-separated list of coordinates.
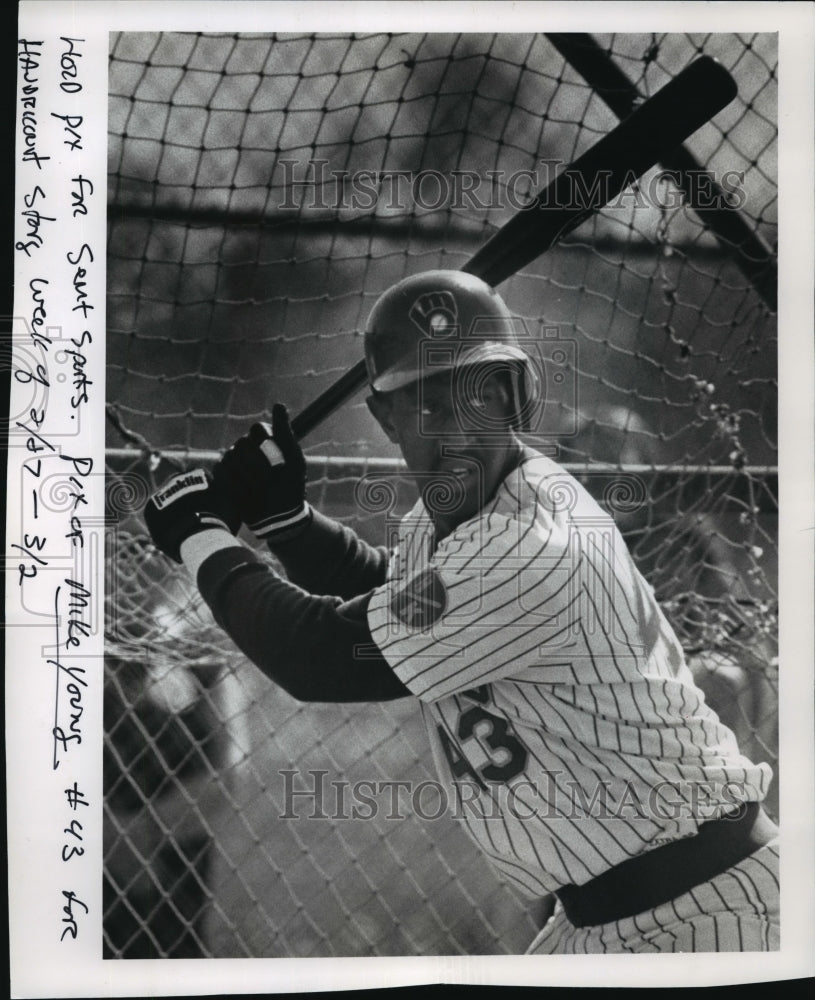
[269, 510, 388, 598]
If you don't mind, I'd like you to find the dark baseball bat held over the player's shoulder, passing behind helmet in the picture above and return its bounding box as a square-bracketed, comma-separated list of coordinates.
[292, 56, 737, 440]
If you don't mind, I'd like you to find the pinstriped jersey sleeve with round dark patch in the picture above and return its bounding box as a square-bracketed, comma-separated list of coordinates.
[368, 514, 583, 701]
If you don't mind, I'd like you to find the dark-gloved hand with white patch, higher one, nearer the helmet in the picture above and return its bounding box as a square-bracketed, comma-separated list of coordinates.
[212, 403, 311, 541]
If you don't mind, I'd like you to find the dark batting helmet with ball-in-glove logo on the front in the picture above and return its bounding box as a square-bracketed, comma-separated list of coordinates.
[365, 271, 538, 424]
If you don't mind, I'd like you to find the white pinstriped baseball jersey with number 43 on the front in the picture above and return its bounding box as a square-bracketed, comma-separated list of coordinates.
[368, 453, 771, 895]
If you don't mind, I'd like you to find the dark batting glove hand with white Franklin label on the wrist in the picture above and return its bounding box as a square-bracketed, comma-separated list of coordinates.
[144, 469, 241, 563]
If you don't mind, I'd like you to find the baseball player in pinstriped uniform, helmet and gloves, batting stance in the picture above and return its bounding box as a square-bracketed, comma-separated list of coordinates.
[145, 271, 779, 954]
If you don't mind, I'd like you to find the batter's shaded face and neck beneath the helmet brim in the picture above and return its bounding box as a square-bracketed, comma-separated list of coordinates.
[372, 369, 520, 537]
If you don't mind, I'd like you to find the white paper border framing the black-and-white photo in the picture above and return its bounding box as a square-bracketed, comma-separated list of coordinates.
[6, 0, 815, 997]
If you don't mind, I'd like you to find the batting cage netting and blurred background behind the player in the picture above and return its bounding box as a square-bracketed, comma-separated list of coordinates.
[104, 33, 777, 958]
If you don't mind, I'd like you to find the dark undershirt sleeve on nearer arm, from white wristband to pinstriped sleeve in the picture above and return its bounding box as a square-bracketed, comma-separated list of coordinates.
[198, 545, 410, 702]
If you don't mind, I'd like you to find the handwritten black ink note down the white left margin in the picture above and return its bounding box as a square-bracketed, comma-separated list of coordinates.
[11, 18, 106, 961]
